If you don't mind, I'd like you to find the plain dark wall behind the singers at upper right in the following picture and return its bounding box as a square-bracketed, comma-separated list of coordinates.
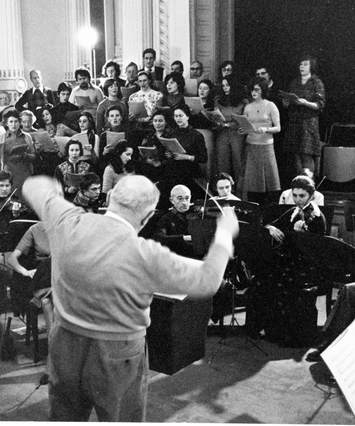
[235, 0, 355, 134]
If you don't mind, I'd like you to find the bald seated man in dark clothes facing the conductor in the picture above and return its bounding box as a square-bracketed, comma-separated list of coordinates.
[155, 185, 193, 257]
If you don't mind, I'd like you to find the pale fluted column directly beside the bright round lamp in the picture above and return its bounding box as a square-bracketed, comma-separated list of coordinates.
[64, 0, 91, 80]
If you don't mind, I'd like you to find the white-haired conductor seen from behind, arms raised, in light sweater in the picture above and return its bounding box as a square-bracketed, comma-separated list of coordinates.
[23, 175, 239, 422]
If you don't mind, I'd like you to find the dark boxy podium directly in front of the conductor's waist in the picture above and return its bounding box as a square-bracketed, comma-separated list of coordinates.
[147, 295, 212, 374]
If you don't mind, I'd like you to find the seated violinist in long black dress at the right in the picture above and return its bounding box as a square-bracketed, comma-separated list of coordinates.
[246, 176, 329, 347]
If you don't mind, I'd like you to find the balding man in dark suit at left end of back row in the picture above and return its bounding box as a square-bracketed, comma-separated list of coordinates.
[15, 70, 55, 113]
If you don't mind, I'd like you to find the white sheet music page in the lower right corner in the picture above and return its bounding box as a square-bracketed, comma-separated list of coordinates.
[321, 320, 355, 414]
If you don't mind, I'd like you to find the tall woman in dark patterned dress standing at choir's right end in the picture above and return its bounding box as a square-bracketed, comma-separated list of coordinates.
[283, 56, 325, 178]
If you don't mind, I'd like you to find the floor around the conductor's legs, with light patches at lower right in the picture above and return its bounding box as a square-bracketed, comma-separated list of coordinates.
[0, 296, 355, 424]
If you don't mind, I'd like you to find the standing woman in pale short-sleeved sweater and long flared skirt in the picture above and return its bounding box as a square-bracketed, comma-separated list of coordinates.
[239, 78, 281, 204]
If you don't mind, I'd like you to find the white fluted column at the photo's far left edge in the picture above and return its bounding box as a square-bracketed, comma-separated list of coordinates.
[0, 0, 24, 103]
